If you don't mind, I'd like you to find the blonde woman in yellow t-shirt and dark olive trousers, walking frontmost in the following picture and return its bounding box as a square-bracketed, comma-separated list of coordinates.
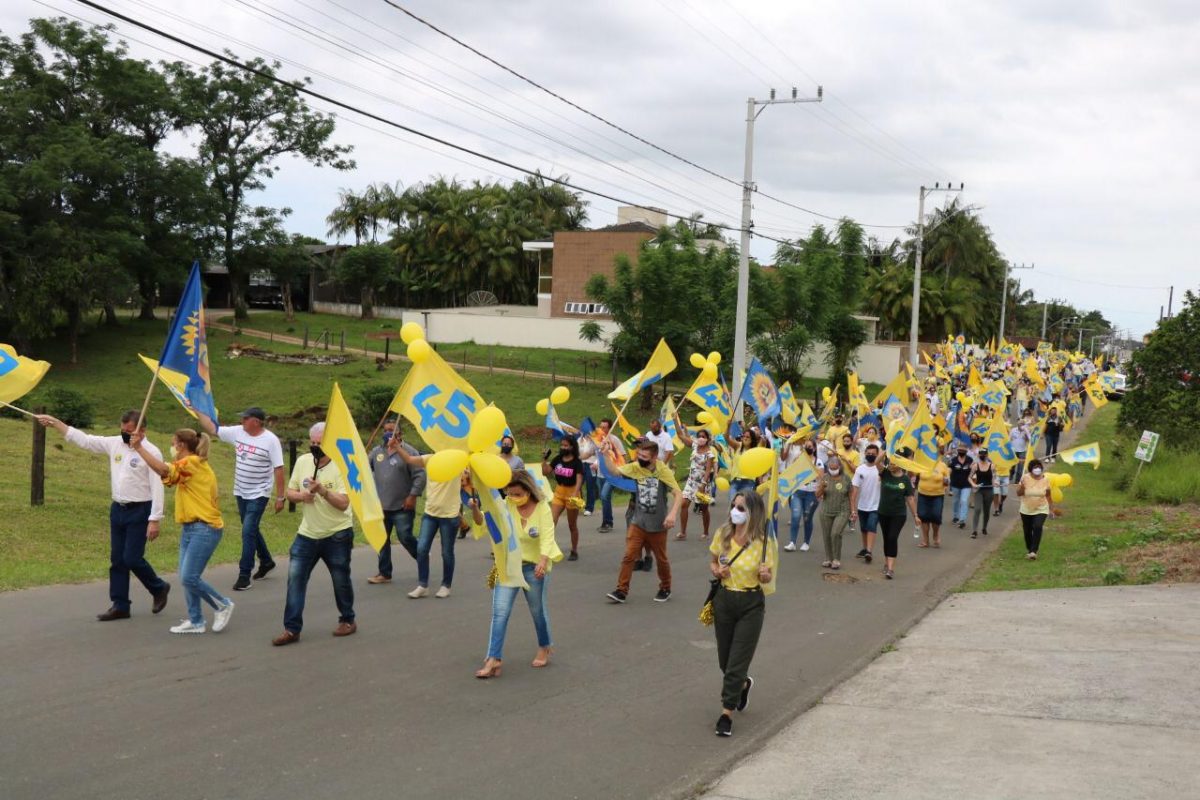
[708, 492, 779, 736]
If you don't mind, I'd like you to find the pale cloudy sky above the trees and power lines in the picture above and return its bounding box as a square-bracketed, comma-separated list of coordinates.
[0, 0, 1200, 333]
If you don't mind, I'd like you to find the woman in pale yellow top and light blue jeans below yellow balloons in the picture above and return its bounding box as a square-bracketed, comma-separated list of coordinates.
[470, 469, 563, 678]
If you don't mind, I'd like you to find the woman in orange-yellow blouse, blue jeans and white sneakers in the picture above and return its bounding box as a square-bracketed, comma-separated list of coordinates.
[130, 428, 233, 633]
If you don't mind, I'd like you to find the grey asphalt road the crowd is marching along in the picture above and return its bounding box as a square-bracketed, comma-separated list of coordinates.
[0, 494, 1019, 800]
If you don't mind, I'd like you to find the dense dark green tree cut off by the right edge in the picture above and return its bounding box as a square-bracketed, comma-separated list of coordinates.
[1118, 291, 1200, 449]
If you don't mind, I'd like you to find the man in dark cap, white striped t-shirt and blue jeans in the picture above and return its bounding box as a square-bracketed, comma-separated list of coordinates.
[199, 405, 284, 591]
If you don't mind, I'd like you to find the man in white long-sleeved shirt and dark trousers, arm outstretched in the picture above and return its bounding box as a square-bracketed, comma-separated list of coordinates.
[35, 410, 170, 622]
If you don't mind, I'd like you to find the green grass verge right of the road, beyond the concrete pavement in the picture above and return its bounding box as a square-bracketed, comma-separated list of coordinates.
[962, 403, 1200, 591]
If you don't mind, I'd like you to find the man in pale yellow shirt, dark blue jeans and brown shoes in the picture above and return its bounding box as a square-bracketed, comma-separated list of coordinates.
[271, 422, 359, 646]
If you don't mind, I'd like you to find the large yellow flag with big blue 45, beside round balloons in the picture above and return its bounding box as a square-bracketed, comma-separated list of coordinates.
[389, 350, 485, 451]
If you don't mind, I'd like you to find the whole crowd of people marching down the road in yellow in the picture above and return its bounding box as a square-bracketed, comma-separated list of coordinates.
[30, 341, 1105, 735]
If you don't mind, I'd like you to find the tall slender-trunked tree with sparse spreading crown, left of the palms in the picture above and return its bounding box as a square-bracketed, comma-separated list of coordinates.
[173, 59, 354, 319]
